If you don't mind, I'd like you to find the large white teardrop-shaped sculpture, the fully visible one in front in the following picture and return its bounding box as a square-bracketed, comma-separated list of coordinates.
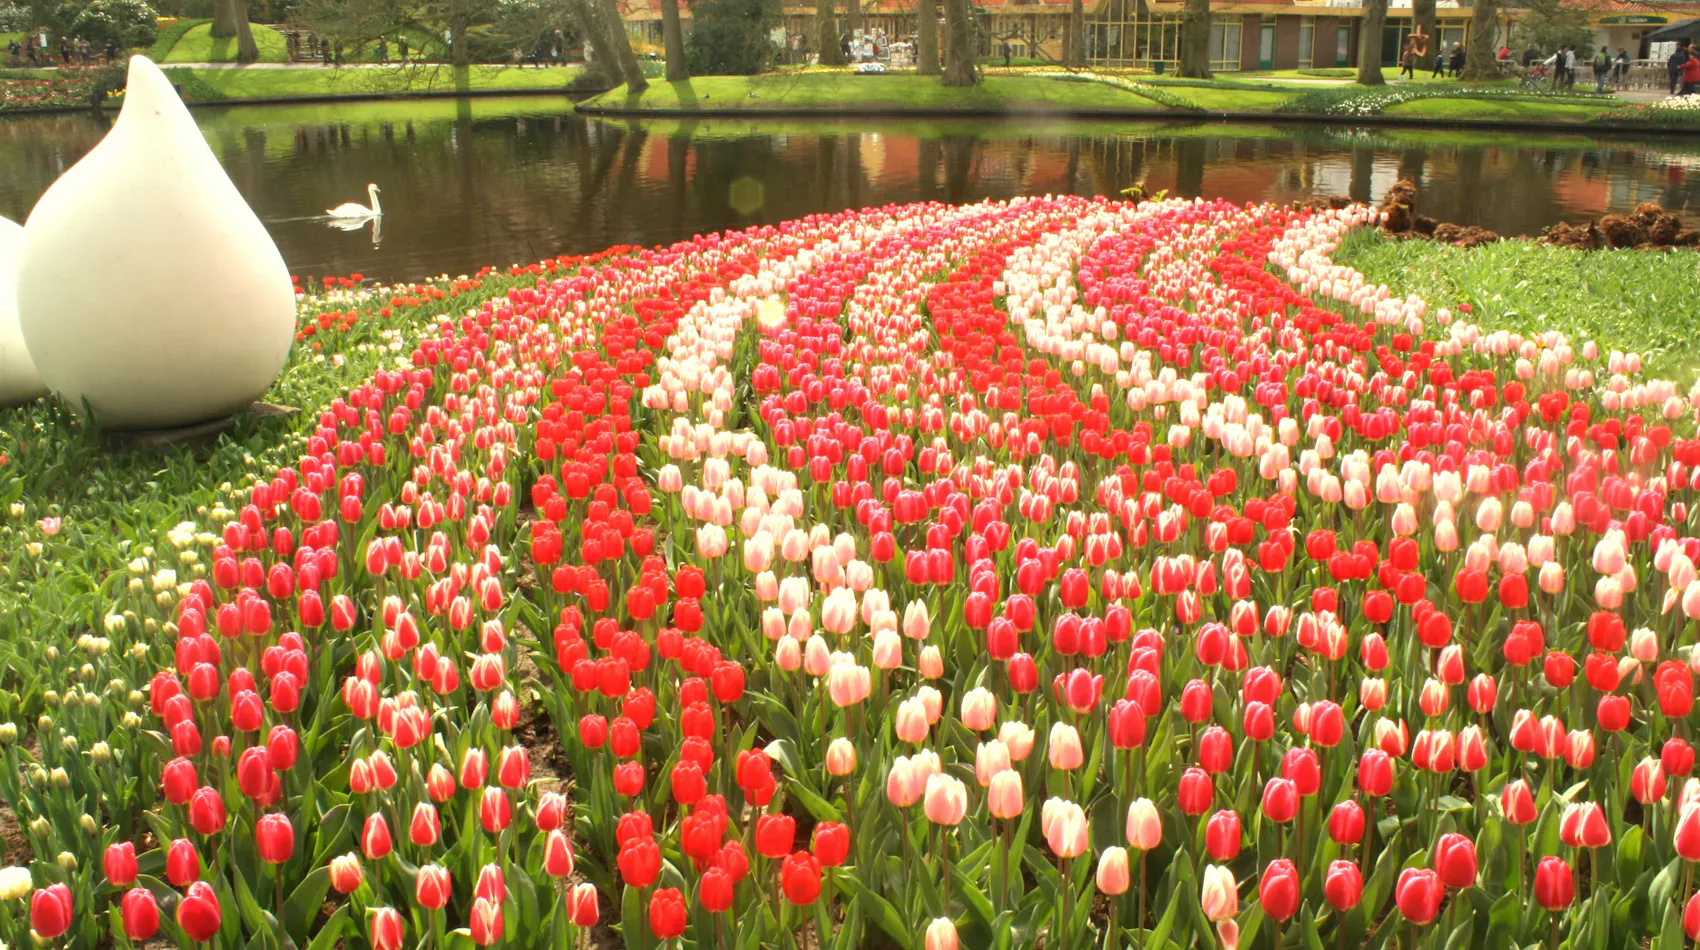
[17, 56, 296, 428]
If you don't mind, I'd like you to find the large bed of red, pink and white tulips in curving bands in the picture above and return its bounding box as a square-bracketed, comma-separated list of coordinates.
[0, 197, 1700, 950]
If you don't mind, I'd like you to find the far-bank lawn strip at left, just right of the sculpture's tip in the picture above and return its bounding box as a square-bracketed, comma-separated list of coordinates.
[178, 65, 578, 99]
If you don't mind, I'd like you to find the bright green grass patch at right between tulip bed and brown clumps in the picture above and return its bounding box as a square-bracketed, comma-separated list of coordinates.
[1335, 231, 1700, 386]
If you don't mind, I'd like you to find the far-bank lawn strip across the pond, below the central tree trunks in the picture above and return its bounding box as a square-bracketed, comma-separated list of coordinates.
[588, 73, 1165, 112]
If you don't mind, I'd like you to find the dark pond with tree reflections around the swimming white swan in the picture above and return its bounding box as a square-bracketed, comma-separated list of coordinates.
[0, 97, 1700, 279]
